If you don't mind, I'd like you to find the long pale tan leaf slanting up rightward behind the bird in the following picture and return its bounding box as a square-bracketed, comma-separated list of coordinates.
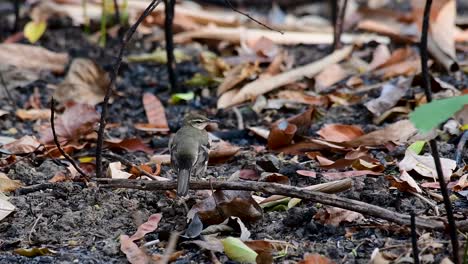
[218, 47, 352, 108]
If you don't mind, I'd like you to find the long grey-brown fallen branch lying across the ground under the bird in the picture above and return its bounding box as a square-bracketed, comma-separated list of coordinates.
[97, 179, 468, 231]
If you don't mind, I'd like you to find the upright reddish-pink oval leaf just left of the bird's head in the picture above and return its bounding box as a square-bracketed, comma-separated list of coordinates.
[143, 93, 169, 131]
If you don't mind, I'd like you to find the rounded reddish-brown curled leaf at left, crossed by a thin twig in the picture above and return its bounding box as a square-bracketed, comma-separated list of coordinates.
[40, 103, 99, 144]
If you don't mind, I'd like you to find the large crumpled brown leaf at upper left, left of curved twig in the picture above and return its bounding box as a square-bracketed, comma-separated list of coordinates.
[54, 58, 110, 105]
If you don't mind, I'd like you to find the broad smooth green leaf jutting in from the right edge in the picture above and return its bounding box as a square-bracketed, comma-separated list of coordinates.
[410, 95, 468, 133]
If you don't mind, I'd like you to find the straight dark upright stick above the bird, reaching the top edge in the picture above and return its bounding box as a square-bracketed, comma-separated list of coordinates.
[164, 0, 178, 91]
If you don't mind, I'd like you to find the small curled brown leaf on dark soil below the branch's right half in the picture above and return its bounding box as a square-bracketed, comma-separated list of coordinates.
[314, 206, 364, 226]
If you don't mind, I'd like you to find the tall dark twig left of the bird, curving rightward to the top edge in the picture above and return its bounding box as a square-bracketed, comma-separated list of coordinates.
[96, 0, 161, 178]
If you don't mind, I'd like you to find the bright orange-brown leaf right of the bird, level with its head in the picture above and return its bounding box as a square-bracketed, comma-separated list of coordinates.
[317, 124, 364, 143]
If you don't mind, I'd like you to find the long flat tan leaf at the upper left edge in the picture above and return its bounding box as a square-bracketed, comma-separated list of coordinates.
[0, 43, 69, 74]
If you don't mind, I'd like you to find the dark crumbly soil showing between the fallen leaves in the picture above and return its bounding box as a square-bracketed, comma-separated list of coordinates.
[0, 1, 468, 263]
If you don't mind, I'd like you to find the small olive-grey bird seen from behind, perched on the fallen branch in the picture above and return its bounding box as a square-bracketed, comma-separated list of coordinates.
[169, 114, 216, 196]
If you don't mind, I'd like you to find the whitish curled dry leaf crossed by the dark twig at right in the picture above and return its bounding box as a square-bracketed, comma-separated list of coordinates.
[398, 149, 457, 180]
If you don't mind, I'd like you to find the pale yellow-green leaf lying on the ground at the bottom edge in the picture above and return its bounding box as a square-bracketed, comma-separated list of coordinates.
[222, 237, 258, 263]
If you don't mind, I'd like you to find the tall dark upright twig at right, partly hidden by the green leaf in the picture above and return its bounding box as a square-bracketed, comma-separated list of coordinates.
[419, 0, 460, 264]
